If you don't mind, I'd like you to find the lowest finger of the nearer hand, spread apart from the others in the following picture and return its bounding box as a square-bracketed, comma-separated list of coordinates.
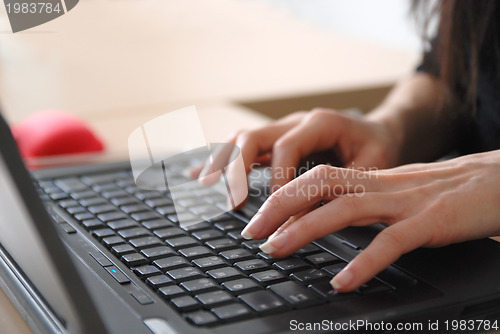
[331, 217, 431, 292]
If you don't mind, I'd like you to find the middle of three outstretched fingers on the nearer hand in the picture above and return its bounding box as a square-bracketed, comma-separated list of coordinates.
[261, 193, 400, 257]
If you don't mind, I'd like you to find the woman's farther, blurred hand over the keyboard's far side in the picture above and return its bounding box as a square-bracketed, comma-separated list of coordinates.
[192, 109, 398, 191]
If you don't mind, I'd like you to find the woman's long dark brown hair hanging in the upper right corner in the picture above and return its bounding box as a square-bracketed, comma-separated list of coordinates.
[412, 0, 500, 112]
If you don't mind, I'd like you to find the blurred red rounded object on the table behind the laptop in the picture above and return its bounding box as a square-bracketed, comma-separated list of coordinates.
[12, 110, 104, 158]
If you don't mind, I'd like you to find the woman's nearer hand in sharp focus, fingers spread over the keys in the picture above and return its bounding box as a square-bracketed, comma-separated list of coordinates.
[242, 150, 500, 292]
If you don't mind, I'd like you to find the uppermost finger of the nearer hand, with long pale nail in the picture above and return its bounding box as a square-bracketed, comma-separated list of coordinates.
[242, 165, 383, 239]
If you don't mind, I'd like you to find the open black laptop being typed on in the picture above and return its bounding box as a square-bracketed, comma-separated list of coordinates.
[0, 113, 500, 333]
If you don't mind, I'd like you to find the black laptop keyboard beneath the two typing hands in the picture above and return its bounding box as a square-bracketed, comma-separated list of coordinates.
[39, 171, 392, 326]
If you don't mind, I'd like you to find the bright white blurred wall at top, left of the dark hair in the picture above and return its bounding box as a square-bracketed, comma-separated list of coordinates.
[266, 0, 421, 52]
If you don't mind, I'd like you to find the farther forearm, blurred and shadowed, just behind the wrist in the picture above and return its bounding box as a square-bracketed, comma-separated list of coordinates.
[366, 73, 461, 164]
